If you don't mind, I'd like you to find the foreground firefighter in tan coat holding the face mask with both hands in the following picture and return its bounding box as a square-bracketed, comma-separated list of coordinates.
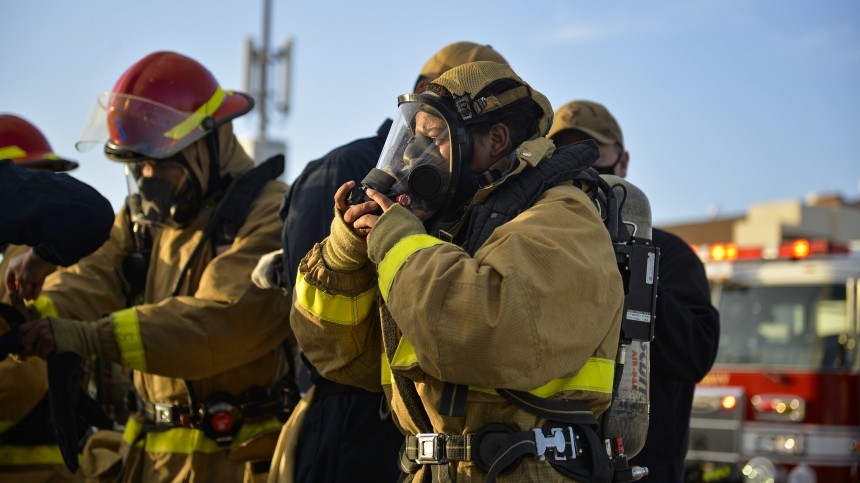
[291, 61, 623, 482]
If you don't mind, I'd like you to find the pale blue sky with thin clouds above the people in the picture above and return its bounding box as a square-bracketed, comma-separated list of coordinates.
[0, 0, 860, 225]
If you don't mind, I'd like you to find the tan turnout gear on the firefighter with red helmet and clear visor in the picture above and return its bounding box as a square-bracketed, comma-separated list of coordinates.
[39, 124, 291, 482]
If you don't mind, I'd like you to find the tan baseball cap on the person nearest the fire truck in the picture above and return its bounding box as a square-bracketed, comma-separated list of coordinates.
[546, 100, 624, 146]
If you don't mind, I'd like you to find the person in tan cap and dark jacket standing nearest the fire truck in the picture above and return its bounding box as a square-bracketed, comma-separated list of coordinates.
[547, 100, 720, 483]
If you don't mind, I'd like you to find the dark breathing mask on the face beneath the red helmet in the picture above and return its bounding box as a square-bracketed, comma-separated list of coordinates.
[125, 160, 200, 228]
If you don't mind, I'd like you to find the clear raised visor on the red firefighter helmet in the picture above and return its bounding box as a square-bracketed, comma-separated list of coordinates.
[75, 92, 208, 161]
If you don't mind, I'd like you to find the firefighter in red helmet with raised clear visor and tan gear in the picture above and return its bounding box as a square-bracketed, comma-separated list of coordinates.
[14, 51, 292, 482]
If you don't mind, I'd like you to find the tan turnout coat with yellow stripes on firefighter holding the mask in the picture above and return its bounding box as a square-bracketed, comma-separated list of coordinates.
[291, 144, 623, 482]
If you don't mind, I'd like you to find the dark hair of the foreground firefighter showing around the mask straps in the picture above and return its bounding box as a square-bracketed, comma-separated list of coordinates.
[427, 79, 543, 148]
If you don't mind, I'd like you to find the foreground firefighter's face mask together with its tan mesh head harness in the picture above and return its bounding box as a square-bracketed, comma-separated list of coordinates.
[350, 61, 552, 221]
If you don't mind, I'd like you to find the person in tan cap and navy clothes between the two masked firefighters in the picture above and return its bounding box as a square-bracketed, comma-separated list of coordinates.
[254, 41, 507, 482]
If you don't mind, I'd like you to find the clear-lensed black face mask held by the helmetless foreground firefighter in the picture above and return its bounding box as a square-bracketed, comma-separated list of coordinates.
[350, 93, 471, 220]
